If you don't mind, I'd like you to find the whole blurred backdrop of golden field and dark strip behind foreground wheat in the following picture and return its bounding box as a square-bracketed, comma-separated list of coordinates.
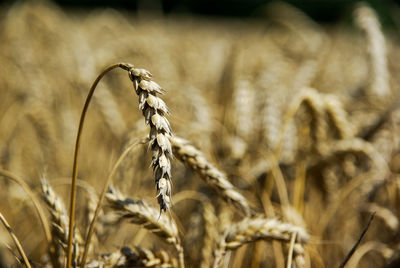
[0, 0, 400, 267]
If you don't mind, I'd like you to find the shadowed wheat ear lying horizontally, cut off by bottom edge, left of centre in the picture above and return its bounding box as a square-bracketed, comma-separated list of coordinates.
[86, 247, 177, 268]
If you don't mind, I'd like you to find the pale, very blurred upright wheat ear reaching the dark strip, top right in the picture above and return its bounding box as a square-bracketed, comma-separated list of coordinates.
[354, 4, 390, 97]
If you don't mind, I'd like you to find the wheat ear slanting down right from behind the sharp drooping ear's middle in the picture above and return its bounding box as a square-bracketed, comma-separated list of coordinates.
[170, 137, 254, 216]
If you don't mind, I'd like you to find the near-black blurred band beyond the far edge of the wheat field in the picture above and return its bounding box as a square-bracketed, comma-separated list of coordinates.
[2, 0, 399, 26]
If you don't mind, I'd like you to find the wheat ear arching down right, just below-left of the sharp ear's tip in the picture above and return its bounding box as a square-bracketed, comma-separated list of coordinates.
[106, 187, 184, 268]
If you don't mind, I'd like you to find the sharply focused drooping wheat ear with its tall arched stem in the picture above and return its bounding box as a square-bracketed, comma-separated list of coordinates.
[67, 63, 172, 268]
